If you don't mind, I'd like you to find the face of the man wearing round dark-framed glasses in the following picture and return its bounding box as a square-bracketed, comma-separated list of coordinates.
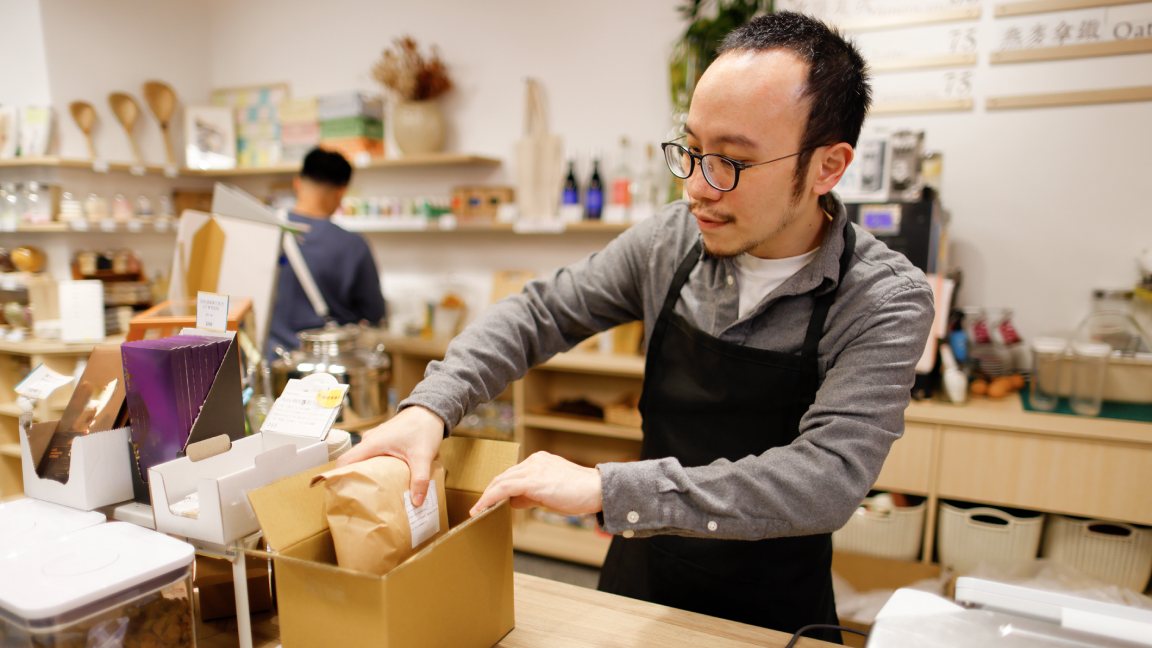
[683, 50, 820, 258]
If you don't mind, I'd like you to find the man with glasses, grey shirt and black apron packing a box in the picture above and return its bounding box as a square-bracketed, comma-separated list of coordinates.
[344, 13, 932, 641]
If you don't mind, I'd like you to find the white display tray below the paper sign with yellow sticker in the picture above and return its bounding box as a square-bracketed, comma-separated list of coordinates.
[147, 431, 328, 545]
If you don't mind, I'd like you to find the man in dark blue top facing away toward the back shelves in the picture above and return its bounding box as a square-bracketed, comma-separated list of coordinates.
[265, 149, 385, 357]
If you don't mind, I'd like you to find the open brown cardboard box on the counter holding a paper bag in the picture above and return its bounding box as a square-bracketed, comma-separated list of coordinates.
[249, 437, 518, 648]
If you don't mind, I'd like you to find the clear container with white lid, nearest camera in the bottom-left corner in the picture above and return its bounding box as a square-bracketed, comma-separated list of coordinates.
[0, 522, 196, 648]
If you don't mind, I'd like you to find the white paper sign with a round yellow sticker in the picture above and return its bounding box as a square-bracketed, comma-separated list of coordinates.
[260, 374, 348, 439]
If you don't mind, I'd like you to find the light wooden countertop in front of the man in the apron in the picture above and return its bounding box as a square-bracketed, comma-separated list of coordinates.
[197, 573, 832, 648]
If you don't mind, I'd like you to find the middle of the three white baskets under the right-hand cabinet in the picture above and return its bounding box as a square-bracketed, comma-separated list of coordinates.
[939, 502, 1044, 574]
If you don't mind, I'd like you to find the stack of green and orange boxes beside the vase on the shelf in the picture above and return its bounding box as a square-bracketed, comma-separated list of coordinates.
[318, 91, 384, 164]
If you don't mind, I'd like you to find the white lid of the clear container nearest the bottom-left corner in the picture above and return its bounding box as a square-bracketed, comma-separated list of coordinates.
[0, 522, 195, 626]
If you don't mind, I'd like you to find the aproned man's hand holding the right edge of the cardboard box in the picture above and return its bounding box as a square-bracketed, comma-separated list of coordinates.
[470, 452, 604, 515]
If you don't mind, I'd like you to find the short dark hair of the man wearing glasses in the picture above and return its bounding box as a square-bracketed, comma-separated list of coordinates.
[718, 12, 872, 200]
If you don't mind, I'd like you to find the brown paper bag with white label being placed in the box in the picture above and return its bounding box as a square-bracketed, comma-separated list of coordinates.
[312, 457, 448, 575]
